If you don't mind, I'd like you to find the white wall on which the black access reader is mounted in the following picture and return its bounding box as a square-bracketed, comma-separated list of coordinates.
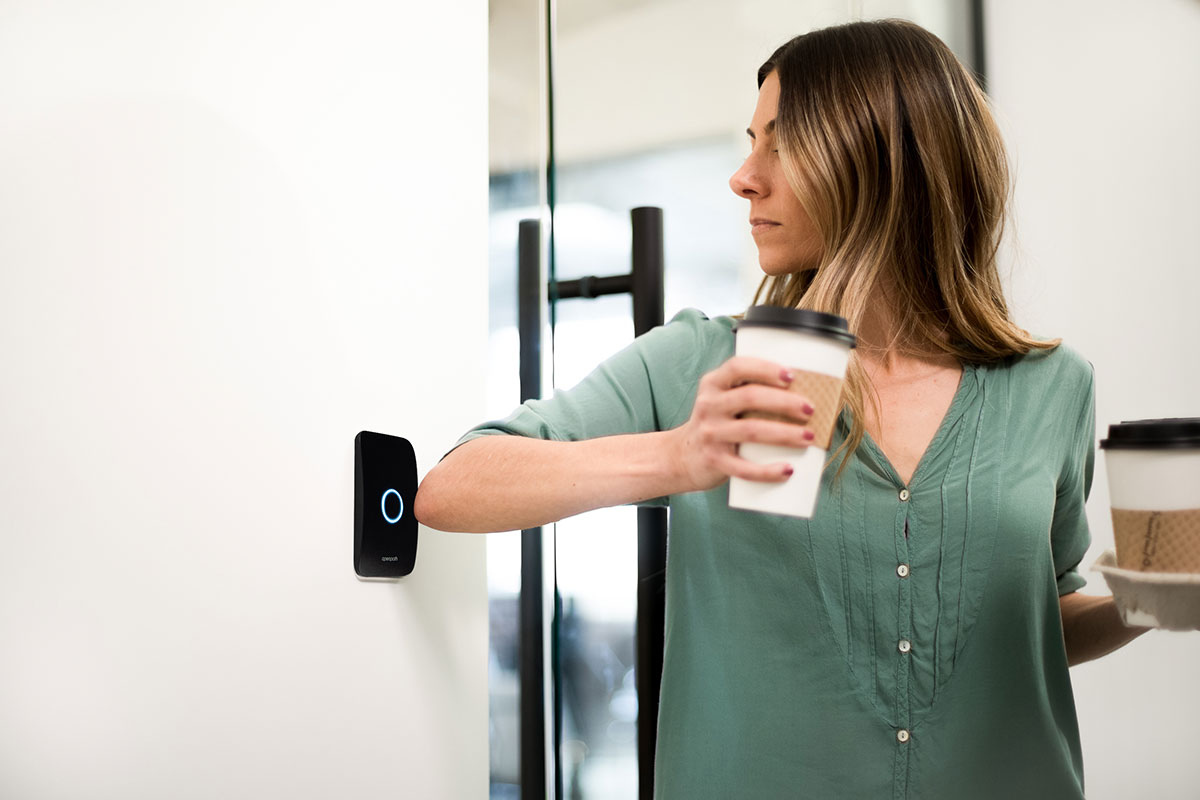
[0, 0, 487, 800]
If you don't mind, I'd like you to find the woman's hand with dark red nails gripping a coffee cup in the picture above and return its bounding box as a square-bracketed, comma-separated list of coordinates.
[672, 356, 814, 492]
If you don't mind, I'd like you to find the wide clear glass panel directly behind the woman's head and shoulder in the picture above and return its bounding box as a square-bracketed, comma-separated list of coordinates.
[552, 0, 971, 800]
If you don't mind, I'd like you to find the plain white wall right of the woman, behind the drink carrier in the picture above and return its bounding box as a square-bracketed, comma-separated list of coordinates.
[986, 0, 1200, 800]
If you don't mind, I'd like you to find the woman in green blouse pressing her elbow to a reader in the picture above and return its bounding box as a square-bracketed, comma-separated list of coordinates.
[415, 20, 1141, 800]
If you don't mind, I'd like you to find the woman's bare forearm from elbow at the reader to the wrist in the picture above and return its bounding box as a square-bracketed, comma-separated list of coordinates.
[414, 431, 690, 533]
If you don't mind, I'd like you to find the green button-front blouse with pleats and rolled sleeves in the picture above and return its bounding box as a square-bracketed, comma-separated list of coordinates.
[455, 309, 1094, 800]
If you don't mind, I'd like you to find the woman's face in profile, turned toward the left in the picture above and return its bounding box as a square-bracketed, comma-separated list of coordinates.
[730, 72, 821, 275]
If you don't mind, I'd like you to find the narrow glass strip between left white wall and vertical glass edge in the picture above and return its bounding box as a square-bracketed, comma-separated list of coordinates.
[485, 0, 554, 800]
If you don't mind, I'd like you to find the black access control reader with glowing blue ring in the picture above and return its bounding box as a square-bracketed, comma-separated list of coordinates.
[354, 431, 416, 578]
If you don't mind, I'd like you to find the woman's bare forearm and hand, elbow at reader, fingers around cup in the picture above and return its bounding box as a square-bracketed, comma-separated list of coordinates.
[414, 356, 812, 533]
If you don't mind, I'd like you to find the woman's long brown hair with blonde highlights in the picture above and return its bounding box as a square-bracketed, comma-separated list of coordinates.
[734, 19, 1058, 475]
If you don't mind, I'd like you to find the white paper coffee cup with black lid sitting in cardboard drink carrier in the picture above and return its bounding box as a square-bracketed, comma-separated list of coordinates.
[1100, 417, 1200, 575]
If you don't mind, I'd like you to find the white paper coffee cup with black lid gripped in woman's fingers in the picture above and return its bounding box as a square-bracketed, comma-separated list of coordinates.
[730, 306, 856, 518]
